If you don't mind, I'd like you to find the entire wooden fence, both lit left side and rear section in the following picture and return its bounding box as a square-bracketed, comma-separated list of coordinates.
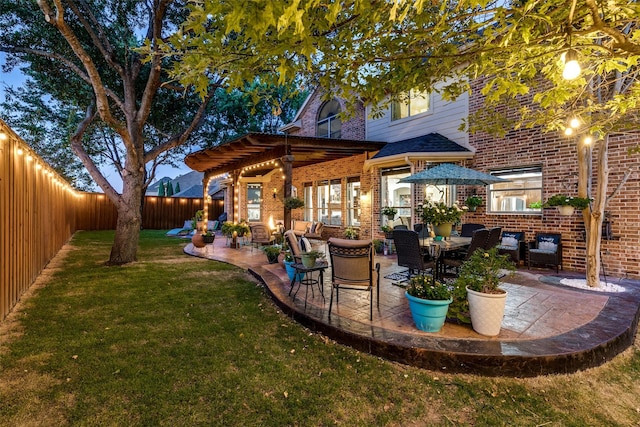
[0, 120, 223, 321]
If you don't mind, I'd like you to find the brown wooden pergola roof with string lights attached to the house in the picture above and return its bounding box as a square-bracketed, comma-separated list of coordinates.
[185, 133, 386, 229]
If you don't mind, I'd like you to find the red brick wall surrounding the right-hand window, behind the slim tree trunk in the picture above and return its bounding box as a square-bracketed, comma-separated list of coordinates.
[459, 78, 640, 279]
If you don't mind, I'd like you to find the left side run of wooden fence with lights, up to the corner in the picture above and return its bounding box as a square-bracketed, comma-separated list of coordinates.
[0, 120, 82, 320]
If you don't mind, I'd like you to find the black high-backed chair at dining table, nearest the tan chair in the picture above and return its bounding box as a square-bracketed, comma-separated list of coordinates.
[393, 230, 440, 279]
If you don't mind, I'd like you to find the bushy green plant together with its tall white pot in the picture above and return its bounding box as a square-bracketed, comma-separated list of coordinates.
[455, 247, 515, 336]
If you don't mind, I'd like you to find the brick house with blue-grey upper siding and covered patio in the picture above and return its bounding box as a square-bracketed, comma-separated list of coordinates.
[185, 82, 640, 279]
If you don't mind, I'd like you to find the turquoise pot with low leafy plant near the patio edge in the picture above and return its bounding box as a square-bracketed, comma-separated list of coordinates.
[405, 274, 453, 332]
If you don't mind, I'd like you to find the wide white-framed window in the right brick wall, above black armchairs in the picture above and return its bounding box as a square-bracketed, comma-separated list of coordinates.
[488, 166, 542, 214]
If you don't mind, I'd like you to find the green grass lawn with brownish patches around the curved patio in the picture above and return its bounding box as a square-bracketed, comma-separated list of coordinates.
[0, 231, 640, 426]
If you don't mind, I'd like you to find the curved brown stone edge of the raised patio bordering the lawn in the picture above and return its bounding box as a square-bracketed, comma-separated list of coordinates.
[185, 245, 640, 377]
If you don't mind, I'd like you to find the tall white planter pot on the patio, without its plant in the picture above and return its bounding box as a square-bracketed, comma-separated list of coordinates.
[467, 288, 507, 337]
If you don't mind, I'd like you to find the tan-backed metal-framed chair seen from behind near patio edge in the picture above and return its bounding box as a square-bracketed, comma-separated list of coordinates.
[327, 237, 380, 320]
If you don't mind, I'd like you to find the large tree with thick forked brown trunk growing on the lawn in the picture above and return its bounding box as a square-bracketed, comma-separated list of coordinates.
[0, 0, 300, 264]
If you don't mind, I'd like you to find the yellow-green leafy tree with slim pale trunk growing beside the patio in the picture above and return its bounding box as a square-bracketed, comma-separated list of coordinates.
[165, 0, 640, 286]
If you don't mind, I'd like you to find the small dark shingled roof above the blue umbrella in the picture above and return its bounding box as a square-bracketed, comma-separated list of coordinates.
[365, 133, 474, 169]
